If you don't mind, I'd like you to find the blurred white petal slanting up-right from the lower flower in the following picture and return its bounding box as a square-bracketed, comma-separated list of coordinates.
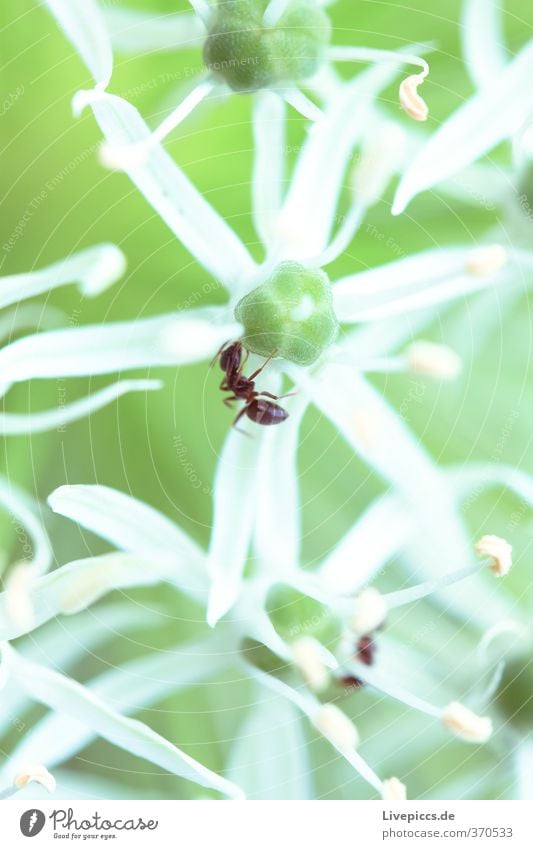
[320, 495, 414, 595]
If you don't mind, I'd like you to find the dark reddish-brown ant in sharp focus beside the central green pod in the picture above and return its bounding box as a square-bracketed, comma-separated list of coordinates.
[213, 342, 293, 427]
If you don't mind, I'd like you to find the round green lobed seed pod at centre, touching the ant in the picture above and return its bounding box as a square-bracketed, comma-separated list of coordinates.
[235, 262, 339, 366]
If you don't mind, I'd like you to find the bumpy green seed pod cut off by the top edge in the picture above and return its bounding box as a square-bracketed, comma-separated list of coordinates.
[204, 0, 331, 92]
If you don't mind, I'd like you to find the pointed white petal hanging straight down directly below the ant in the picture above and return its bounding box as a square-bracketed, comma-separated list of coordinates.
[207, 425, 262, 626]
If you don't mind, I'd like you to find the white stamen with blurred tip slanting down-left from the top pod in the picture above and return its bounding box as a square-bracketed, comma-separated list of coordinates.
[100, 79, 215, 171]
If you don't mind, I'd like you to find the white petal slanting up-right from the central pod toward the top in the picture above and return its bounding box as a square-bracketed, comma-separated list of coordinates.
[277, 66, 402, 260]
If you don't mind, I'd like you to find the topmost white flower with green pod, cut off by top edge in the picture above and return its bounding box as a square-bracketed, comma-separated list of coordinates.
[41, 0, 429, 171]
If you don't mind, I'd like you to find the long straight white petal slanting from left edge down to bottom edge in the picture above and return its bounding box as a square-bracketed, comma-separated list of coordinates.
[4, 647, 243, 798]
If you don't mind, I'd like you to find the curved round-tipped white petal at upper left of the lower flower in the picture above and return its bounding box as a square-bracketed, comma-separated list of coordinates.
[48, 484, 206, 600]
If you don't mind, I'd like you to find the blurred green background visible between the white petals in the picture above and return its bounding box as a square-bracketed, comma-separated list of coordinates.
[0, 0, 533, 798]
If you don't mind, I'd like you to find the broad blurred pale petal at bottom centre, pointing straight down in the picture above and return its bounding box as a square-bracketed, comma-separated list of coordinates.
[228, 694, 312, 800]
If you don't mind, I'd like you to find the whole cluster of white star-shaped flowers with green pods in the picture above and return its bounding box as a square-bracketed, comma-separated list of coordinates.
[0, 0, 533, 800]
